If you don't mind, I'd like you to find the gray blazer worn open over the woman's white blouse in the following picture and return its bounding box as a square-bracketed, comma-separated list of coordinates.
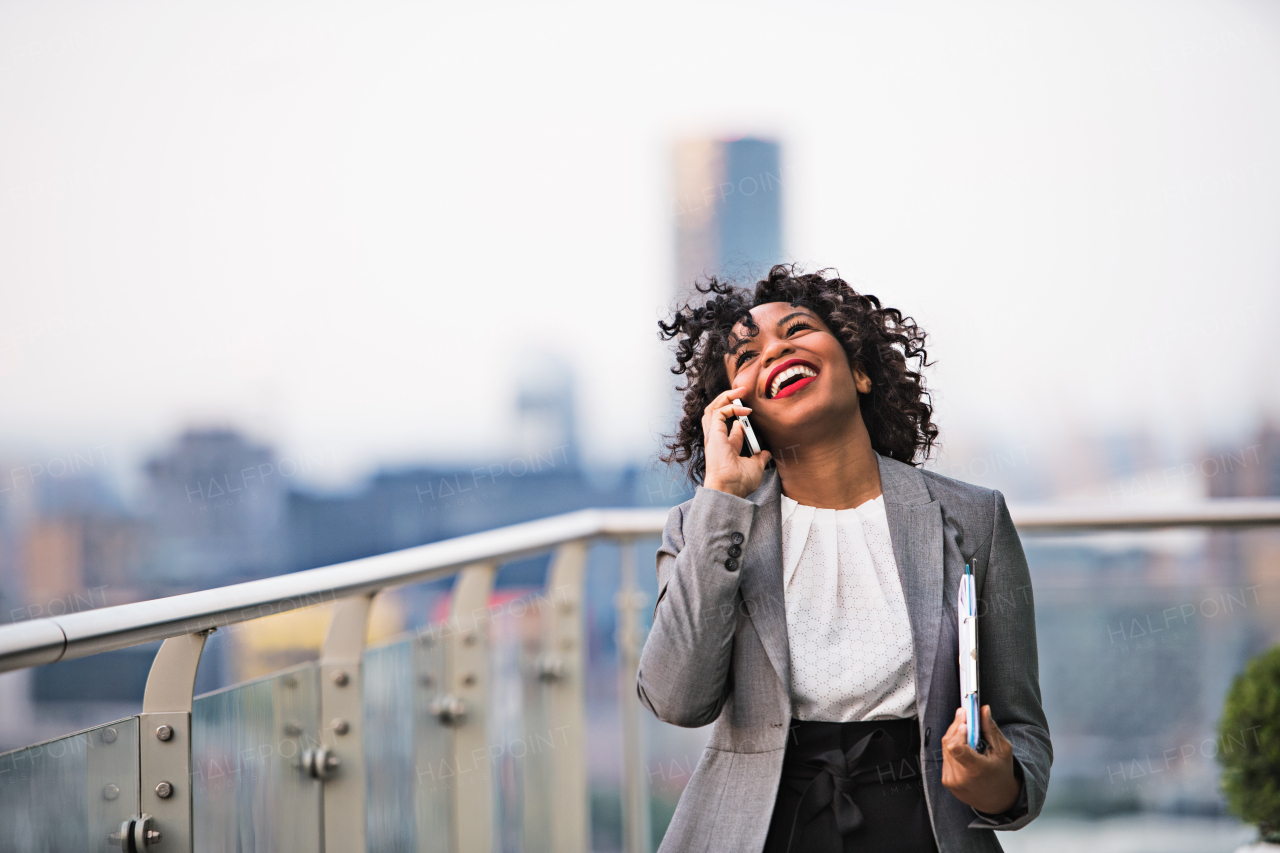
[636, 456, 1053, 853]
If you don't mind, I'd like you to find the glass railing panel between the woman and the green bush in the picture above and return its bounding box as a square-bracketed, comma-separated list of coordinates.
[1018, 529, 1280, 831]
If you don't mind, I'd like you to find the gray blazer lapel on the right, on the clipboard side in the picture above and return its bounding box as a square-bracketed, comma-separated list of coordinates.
[879, 456, 943, 720]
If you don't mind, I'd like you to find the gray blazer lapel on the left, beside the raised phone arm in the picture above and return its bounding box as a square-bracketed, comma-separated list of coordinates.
[741, 467, 791, 699]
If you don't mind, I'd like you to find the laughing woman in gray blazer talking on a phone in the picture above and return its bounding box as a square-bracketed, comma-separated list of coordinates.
[637, 266, 1053, 853]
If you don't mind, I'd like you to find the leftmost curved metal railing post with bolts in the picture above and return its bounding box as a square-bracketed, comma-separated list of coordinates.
[139, 629, 212, 853]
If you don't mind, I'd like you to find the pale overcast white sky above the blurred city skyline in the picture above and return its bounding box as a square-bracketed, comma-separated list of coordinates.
[0, 0, 1280, 479]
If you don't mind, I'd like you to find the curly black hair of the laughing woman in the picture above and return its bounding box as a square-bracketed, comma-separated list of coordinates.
[658, 264, 938, 483]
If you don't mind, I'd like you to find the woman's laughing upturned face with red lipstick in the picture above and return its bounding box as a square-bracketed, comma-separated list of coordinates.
[724, 302, 872, 445]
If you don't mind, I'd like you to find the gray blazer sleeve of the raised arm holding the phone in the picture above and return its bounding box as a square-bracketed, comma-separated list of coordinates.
[636, 487, 756, 727]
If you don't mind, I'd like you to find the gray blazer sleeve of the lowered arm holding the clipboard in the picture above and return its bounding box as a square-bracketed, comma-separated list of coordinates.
[969, 492, 1053, 830]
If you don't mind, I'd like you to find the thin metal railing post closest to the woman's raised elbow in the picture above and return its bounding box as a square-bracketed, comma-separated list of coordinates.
[614, 537, 652, 853]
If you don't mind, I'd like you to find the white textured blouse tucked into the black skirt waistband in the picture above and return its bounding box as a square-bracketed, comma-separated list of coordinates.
[782, 494, 915, 722]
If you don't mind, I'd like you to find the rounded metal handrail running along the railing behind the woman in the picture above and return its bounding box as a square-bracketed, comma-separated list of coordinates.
[0, 498, 1280, 672]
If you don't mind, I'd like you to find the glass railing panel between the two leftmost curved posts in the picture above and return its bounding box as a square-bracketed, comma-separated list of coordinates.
[191, 663, 323, 853]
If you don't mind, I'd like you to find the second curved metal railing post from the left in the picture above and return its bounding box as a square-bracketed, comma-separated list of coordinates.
[316, 593, 374, 853]
